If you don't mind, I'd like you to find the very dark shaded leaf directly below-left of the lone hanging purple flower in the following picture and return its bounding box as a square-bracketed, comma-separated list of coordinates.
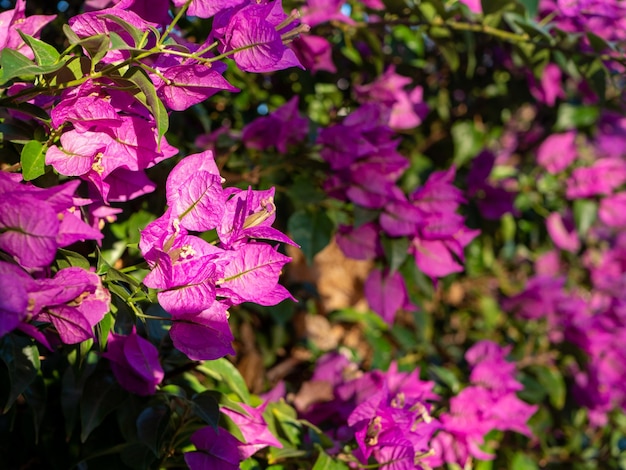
[80, 374, 127, 442]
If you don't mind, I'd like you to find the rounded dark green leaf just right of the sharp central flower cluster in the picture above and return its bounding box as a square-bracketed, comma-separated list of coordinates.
[287, 210, 335, 264]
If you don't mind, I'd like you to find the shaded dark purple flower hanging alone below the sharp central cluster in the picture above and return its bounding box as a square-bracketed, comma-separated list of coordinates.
[102, 326, 164, 396]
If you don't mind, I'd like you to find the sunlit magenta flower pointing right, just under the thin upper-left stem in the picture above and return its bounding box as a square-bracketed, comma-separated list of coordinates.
[153, 62, 239, 111]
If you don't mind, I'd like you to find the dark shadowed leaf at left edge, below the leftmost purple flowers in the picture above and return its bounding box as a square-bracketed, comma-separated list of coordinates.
[0, 334, 40, 413]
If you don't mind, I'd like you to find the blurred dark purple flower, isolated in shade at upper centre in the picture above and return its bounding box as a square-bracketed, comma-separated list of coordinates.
[241, 95, 308, 154]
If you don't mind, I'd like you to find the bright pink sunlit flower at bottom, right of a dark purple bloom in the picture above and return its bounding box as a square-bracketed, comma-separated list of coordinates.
[221, 402, 283, 460]
